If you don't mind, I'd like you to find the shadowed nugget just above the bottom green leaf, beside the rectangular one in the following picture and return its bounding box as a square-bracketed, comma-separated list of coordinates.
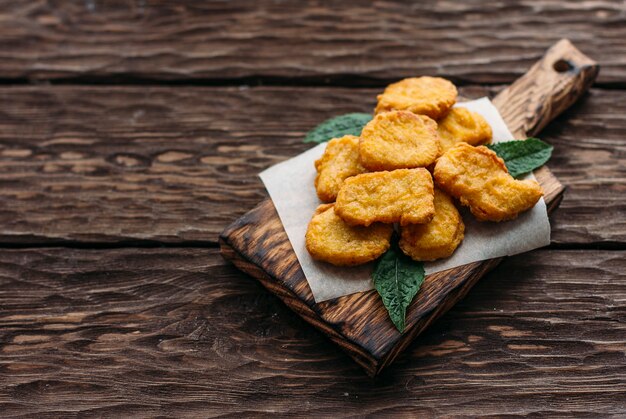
[399, 188, 465, 261]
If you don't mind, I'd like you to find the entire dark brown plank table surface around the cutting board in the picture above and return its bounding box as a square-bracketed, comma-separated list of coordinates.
[0, 0, 626, 417]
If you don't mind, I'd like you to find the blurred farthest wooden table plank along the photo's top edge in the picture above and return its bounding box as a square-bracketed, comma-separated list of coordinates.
[0, 0, 626, 85]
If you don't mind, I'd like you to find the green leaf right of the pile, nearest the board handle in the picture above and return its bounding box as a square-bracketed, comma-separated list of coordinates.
[487, 138, 554, 178]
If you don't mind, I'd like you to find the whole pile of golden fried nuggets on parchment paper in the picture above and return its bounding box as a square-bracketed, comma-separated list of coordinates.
[306, 77, 543, 266]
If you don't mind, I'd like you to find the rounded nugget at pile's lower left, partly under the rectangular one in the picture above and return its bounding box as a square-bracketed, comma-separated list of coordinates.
[305, 204, 393, 266]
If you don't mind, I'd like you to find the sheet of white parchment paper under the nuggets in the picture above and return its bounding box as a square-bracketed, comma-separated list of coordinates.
[260, 98, 550, 302]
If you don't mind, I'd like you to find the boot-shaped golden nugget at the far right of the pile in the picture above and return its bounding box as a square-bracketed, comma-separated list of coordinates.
[434, 143, 543, 221]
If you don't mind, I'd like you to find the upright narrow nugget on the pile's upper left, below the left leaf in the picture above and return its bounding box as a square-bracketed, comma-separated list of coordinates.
[315, 135, 366, 202]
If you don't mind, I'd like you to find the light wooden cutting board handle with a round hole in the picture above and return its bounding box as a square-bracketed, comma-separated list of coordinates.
[493, 39, 600, 138]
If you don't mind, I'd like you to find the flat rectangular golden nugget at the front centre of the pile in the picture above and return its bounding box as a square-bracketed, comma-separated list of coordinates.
[335, 169, 435, 226]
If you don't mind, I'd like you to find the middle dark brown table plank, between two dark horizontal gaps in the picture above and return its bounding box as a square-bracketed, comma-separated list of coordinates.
[0, 86, 626, 244]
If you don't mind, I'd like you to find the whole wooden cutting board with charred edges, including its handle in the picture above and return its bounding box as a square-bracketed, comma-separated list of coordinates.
[220, 40, 599, 375]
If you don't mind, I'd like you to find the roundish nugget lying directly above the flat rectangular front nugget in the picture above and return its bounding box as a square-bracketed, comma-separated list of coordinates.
[359, 111, 440, 171]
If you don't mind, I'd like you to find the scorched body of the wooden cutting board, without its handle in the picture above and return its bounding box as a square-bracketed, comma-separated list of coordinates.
[220, 168, 563, 376]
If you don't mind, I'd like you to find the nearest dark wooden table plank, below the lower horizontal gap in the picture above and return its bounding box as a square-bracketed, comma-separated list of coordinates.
[0, 248, 626, 417]
